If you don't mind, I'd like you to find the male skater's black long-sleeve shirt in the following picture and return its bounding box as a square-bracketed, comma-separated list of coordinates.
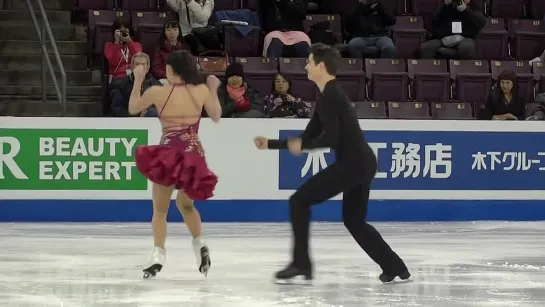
[268, 80, 376, 166]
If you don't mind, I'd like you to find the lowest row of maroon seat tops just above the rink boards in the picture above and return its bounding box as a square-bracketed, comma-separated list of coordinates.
[346, 101, 538, 120]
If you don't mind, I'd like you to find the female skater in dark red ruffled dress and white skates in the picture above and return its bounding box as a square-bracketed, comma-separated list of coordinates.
[129, 50, 221, 278]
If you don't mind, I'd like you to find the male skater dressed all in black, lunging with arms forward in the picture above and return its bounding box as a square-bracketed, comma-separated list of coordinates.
[254, 44, 411, 283]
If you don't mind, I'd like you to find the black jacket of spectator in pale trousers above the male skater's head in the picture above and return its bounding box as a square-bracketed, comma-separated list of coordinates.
[260, 0, 307, 33]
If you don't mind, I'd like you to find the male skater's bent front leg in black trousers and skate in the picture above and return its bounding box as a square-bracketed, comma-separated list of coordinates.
[276, 163, 344, 279]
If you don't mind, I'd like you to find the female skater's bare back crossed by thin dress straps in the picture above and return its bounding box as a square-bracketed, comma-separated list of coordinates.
[153, 84, 210, 130]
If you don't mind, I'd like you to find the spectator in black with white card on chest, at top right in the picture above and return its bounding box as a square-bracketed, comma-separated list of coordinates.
[420, 0, 486, 60]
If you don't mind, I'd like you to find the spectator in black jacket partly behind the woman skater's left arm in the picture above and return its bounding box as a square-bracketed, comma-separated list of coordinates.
[110, 52, 161, 117]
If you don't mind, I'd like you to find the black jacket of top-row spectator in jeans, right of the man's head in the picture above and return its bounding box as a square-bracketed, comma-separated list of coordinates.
[347, 1, 396, 38]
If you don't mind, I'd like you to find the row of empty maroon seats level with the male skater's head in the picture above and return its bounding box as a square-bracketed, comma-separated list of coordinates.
[231, 58, 545, 102]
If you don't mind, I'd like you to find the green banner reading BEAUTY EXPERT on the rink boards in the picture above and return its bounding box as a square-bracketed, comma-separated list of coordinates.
[0, 128, 148, 190]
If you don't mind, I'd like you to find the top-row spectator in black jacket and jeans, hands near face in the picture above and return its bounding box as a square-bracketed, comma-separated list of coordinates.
[347, 0, 396, 59]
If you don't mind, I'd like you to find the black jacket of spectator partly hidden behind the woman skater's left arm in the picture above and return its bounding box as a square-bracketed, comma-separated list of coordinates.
[110, 73, 161, 117]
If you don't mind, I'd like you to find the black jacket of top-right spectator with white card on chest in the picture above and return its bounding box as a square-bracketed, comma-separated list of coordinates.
[433, 1, 486, 39]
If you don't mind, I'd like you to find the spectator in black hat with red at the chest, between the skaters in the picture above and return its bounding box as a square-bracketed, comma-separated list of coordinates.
[218, 63, 265, 118]
